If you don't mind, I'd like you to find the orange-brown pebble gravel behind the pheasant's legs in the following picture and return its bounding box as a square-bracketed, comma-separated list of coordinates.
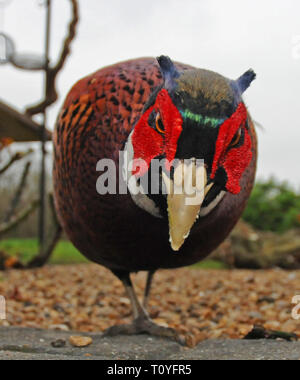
[0, 264, 300, 347]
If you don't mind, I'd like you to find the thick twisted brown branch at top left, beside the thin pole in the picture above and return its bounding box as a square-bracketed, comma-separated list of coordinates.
[26, 0, 79, 116]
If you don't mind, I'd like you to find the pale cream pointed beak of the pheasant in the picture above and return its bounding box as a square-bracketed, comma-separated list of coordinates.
[163, 160, 213, 251]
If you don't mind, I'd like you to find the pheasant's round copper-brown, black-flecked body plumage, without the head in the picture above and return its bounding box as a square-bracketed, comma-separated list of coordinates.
[54, 58, 256, 342]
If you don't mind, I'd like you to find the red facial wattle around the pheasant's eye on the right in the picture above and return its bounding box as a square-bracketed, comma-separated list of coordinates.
[211, 103, 252, 194]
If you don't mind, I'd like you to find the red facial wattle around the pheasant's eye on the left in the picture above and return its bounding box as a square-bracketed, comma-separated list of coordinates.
[132, 89, 183, 177]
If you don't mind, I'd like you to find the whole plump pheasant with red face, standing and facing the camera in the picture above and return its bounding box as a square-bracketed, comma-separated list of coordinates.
[53, 56, 257, 339]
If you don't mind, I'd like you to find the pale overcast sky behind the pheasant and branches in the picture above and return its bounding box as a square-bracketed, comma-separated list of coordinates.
[0, 0, 300, 188]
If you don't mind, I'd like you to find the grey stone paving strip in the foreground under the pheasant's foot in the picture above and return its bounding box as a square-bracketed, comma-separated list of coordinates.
[0, 327, 300, 360]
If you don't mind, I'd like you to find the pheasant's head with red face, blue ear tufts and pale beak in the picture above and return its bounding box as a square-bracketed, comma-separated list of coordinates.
[127, 56, 255, 251]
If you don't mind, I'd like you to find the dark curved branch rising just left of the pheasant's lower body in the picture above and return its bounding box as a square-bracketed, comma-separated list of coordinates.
[26, 194, 62, 269]
